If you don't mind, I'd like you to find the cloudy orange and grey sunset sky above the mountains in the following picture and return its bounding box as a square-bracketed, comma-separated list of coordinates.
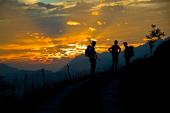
[0, 0, 170, 70]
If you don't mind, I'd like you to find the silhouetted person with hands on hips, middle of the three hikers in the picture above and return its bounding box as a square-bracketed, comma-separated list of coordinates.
[108, 40, 121, 69]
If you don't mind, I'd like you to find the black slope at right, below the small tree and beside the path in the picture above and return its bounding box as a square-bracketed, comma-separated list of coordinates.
[120, 38, 170, 113]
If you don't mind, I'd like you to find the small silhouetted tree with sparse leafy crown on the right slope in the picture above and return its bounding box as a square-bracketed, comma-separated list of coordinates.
[146, 24, 165, 54]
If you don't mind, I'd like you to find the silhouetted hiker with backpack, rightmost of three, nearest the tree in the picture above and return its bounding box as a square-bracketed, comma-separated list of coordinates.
[123, 42, 134, 66]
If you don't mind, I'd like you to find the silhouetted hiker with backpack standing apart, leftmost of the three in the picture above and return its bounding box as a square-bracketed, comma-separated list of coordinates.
[85, 41, 97, 77]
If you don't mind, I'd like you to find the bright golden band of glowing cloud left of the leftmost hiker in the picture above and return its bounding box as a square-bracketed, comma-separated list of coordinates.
[0, 33, 97, 64]
